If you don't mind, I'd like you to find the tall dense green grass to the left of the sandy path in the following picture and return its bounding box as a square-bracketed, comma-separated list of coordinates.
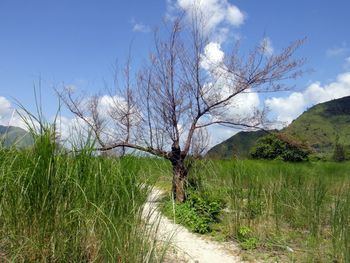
[0, 130, 164, 262]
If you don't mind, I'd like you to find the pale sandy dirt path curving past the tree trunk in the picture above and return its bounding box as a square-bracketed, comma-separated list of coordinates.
[143, 189, 243, 263]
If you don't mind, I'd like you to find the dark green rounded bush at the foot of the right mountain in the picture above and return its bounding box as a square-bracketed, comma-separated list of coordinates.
[251, 134, 309, 162]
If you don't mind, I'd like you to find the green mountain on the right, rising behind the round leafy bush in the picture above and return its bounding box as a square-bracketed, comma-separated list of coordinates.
[207, 96, 350, 159]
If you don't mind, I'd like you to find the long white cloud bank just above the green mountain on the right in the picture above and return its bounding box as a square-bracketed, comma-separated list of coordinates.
[265, 72, 350, 125]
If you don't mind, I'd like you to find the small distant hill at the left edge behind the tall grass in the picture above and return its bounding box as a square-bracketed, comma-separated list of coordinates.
[0, 125, 33, 148]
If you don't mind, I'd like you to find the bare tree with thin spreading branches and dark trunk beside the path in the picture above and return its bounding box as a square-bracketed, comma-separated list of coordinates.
[60, 16, 304, 202]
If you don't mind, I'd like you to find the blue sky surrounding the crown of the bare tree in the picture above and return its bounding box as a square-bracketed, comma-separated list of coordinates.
[0, 0, 350, 144]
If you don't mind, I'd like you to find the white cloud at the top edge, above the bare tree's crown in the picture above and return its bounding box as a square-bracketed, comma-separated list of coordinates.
[167, 0, 246, 41]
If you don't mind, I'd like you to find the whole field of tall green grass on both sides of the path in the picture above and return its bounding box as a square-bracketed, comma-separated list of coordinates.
[0, 127, 350, 262]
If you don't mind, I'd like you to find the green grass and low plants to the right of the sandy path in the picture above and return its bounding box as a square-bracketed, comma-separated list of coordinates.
[160, 160, 350, 262]
